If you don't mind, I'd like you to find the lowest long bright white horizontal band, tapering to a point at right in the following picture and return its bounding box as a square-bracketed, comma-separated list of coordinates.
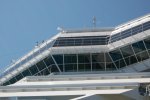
[0, 89, 132, 97]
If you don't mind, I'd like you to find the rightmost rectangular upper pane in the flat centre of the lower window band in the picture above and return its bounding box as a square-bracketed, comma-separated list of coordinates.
[92, 53, 104, 62]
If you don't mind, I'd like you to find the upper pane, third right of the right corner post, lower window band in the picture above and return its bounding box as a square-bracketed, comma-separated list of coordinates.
[132, 41, 146, 53]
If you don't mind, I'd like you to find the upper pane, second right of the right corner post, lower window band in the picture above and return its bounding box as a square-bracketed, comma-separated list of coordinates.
[120, 45, 134, 57]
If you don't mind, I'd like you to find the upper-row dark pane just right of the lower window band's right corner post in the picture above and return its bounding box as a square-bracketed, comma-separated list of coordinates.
[109, 49, 122, 61]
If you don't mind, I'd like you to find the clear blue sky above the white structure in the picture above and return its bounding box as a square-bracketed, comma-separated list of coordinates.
[0, 0, 150, 68]
